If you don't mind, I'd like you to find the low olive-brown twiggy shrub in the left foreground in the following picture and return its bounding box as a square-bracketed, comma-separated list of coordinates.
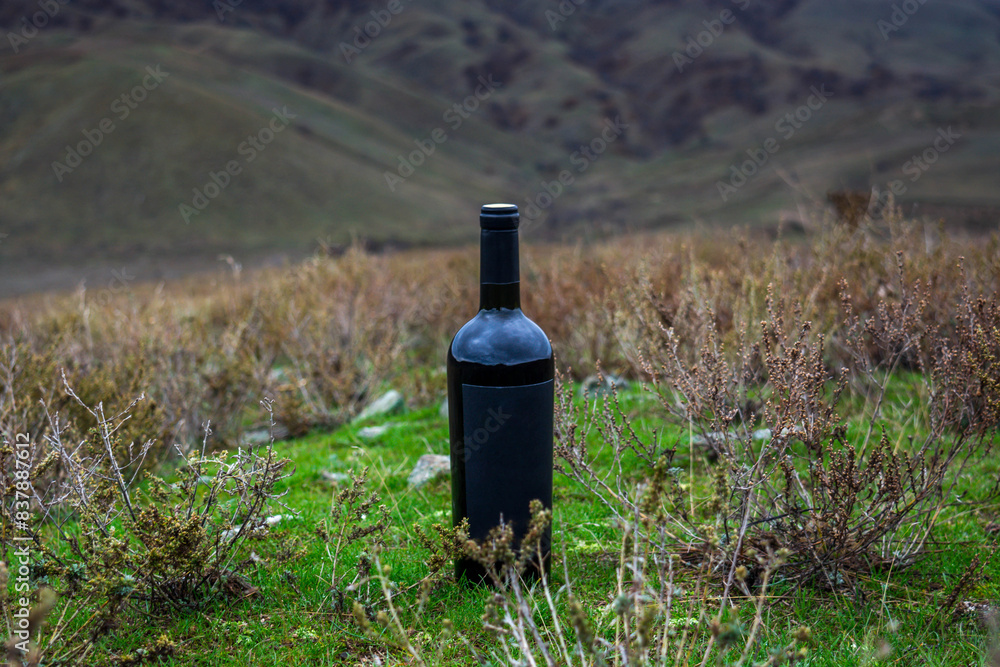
[0, 384, 290, 665]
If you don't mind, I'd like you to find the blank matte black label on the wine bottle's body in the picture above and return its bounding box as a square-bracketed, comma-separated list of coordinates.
[462, 380, 554, 542]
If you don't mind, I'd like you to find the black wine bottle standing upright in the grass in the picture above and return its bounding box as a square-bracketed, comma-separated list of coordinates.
[448, 204, 555, 582]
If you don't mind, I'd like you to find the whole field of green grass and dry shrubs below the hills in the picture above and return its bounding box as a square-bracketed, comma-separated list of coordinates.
[0, 217, 1000, 667]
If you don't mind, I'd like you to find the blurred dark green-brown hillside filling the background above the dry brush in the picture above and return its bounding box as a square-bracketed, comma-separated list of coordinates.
[0, 0, 1000, 291]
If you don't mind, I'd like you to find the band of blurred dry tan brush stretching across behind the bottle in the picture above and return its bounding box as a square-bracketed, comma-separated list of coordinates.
[0, 214, 984, 470]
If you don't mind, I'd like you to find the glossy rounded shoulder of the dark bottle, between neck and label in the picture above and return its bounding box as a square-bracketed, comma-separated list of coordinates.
[448, 308, 552, 366]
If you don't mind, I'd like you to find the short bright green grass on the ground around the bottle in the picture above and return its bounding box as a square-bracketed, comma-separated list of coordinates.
[29, 380, 1000, 667]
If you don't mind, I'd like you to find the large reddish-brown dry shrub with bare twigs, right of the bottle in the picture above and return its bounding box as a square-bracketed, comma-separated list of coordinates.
[557, 214, 1000, 597]
